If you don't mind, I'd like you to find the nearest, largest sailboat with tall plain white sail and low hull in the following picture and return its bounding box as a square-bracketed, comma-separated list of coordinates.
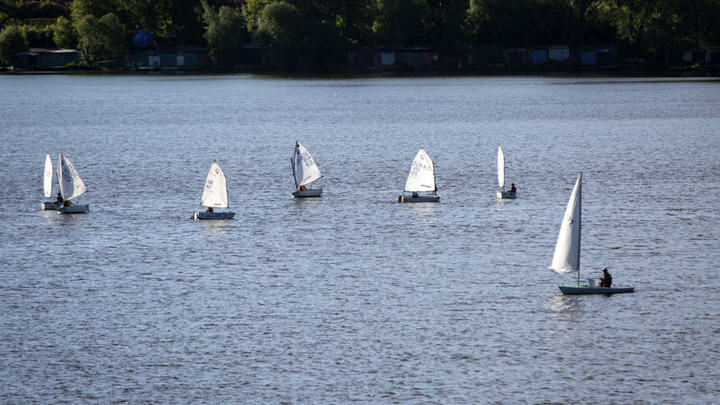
[550, 173, 635, 294]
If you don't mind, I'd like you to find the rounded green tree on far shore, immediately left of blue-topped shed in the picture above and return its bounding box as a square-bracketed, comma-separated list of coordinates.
[75, 13, 125, 65]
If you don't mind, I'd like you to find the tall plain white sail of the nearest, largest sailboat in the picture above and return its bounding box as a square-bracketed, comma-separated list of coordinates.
[550, 173, 582, 274]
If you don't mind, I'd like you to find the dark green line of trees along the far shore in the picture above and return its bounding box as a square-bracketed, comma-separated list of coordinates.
[0, 0, 720, 67]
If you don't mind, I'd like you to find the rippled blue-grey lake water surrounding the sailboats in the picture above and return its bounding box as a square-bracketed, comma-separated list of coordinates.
[0, 75, 720, 404]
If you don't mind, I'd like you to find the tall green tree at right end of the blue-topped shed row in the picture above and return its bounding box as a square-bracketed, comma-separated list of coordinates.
[202, 0, 245, 67]
